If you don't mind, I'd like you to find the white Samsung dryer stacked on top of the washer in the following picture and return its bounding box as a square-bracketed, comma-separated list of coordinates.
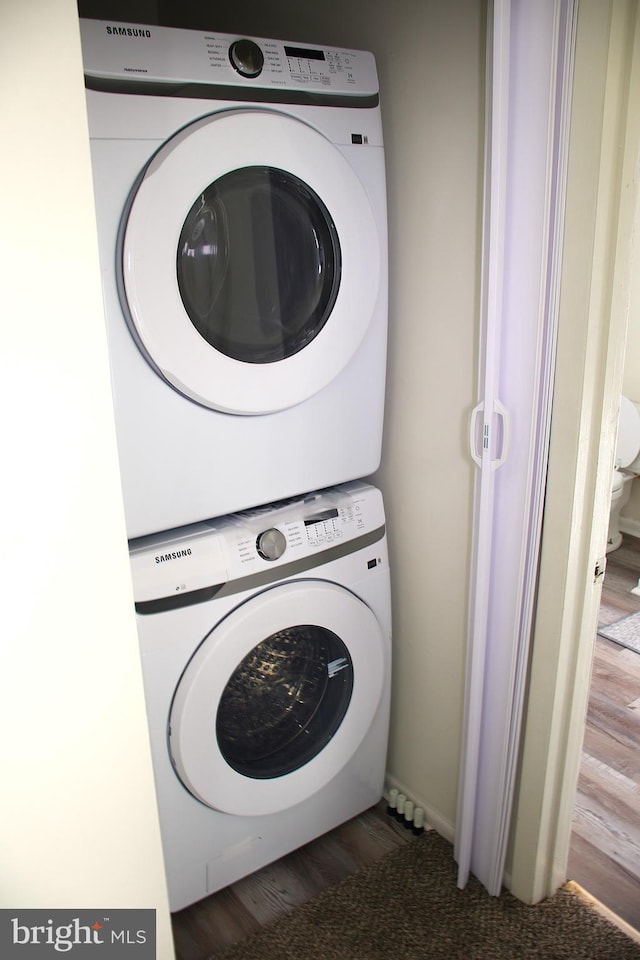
[81, 20, 387, 538]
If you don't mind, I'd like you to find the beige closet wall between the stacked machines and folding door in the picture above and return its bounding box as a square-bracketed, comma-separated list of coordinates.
[377, 2, 484, 836]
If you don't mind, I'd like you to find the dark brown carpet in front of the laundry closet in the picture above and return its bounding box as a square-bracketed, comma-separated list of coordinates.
[210, 831, 640, 960]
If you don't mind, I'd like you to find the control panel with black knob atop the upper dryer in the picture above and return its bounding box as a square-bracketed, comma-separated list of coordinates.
[80, 18, 378, 98]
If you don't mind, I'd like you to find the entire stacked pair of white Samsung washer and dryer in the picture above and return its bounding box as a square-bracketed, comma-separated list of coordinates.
[80, 20, 391, 911]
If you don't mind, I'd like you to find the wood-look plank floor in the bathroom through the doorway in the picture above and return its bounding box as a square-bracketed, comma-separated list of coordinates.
[568, 536, 640, 930]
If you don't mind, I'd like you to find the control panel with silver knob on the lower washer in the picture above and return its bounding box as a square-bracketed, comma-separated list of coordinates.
[129, 481, 385, 605]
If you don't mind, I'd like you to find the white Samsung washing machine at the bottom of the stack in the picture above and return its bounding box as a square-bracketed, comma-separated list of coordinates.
[131, 482, 391, 911]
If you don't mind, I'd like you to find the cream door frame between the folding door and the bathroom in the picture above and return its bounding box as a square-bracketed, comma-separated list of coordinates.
[507, 0, 640, 903]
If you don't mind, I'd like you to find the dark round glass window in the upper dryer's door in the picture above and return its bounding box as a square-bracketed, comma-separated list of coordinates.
[177, 167, 341, 363]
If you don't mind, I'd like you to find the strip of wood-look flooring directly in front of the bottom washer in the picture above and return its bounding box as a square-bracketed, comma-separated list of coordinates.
[173, 802, 413, 960]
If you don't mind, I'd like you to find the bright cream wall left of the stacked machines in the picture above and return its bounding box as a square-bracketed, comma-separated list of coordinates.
[0, 0, 173, 960]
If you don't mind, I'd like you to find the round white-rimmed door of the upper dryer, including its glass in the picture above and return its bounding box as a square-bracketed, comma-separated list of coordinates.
[120, 109, 380, 414]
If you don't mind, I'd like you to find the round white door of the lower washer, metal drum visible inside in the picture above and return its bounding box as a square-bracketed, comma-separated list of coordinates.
[169, 580, 386, 816]
